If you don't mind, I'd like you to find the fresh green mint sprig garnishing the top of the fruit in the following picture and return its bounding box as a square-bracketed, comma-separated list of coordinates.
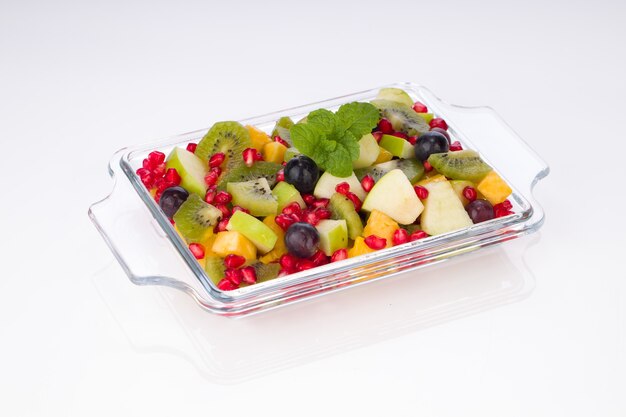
[289, 102, 380, 178]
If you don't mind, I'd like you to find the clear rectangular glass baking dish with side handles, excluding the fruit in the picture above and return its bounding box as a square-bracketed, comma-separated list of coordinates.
[89, 83, 549, 317]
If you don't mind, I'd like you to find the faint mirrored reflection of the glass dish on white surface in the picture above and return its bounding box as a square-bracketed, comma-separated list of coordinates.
[94, 235, 540, 383]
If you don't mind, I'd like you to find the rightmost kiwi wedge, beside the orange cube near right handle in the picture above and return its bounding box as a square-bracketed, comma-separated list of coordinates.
[428, 149, 492, 183]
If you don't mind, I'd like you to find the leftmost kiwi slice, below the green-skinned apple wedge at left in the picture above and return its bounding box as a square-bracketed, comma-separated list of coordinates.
[173, 194, 222, 243]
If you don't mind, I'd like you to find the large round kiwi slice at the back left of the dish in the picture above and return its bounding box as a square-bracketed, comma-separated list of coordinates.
[195, 122, 252, 167]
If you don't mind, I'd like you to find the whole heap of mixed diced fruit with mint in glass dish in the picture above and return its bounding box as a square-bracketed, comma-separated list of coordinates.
[137, 88, 512, 291]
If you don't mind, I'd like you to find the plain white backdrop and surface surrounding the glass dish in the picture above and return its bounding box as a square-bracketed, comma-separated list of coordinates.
[0, 0, 626, 417]
